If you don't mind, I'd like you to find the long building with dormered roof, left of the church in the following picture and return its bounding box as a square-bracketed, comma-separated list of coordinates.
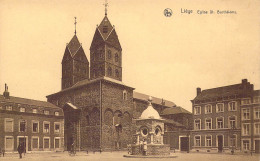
[0, 85, 64, 152]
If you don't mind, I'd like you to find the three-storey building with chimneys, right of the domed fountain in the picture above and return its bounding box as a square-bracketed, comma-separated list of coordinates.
[191, 79, 259, 152]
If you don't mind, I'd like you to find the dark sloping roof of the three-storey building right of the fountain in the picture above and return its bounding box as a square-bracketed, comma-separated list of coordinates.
[194, 82, 253, 100]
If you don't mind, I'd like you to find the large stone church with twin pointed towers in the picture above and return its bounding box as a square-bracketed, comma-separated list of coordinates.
[47, 9, 192, 151]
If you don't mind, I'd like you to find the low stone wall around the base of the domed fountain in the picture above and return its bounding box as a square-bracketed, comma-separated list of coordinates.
[131, 144, 170, 155]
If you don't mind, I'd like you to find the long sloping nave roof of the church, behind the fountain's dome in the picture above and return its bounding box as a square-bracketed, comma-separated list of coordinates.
[133, 91, 176, 107]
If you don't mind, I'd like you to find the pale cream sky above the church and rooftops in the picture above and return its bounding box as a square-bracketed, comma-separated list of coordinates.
[0, 0, 260, 111]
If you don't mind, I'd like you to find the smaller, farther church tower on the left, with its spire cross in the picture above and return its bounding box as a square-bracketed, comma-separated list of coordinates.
[61, 18, 89, 90]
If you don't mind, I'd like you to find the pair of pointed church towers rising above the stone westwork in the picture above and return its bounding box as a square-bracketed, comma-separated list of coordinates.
[61, 15, 122, 90]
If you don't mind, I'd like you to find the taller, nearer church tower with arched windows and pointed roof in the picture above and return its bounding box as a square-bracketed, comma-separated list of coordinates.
[90, 13, 122, 81]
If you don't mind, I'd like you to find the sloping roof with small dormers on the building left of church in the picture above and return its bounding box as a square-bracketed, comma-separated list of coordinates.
[0, 95, 59, 108]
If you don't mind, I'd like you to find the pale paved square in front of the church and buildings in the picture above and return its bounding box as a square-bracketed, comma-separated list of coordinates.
[0, 152, 260, 161]
